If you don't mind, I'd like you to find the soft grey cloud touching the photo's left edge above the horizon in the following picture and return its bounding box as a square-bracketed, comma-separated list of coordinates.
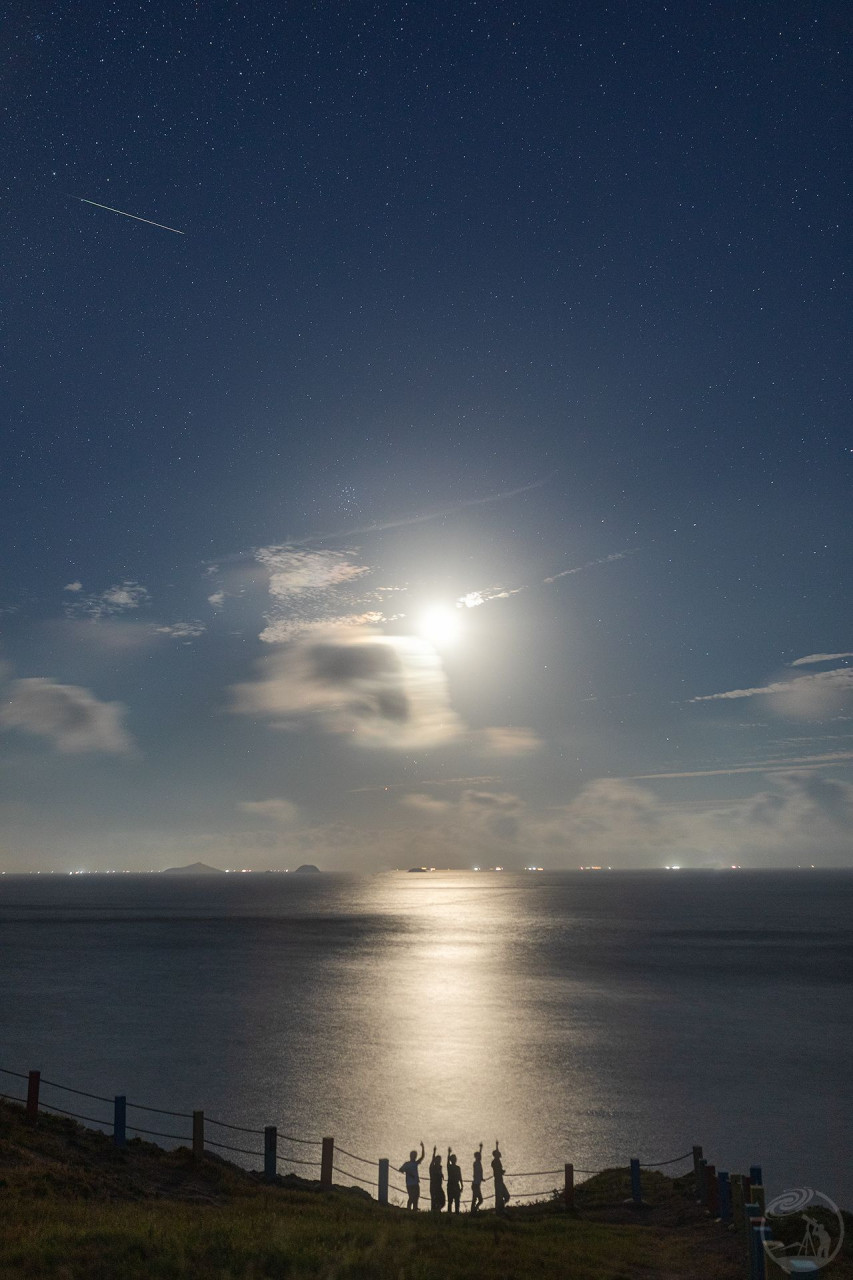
[0, 677, 133, 754]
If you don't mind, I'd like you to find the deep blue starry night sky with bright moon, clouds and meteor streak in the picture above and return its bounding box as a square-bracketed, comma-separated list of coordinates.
[0, 0, 853, 870]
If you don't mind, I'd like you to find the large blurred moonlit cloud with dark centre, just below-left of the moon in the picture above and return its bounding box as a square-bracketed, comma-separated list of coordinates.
[233, 628, 462, 749]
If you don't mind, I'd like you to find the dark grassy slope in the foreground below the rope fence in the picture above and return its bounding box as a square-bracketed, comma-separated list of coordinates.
[0, 1102, 853, 1280]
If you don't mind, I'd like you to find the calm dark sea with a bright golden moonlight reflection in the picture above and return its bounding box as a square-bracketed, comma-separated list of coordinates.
[0, 872, 853, 1208]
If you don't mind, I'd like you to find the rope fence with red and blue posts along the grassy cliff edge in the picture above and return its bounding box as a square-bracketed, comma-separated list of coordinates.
[0, 1066, 770, 1280]
